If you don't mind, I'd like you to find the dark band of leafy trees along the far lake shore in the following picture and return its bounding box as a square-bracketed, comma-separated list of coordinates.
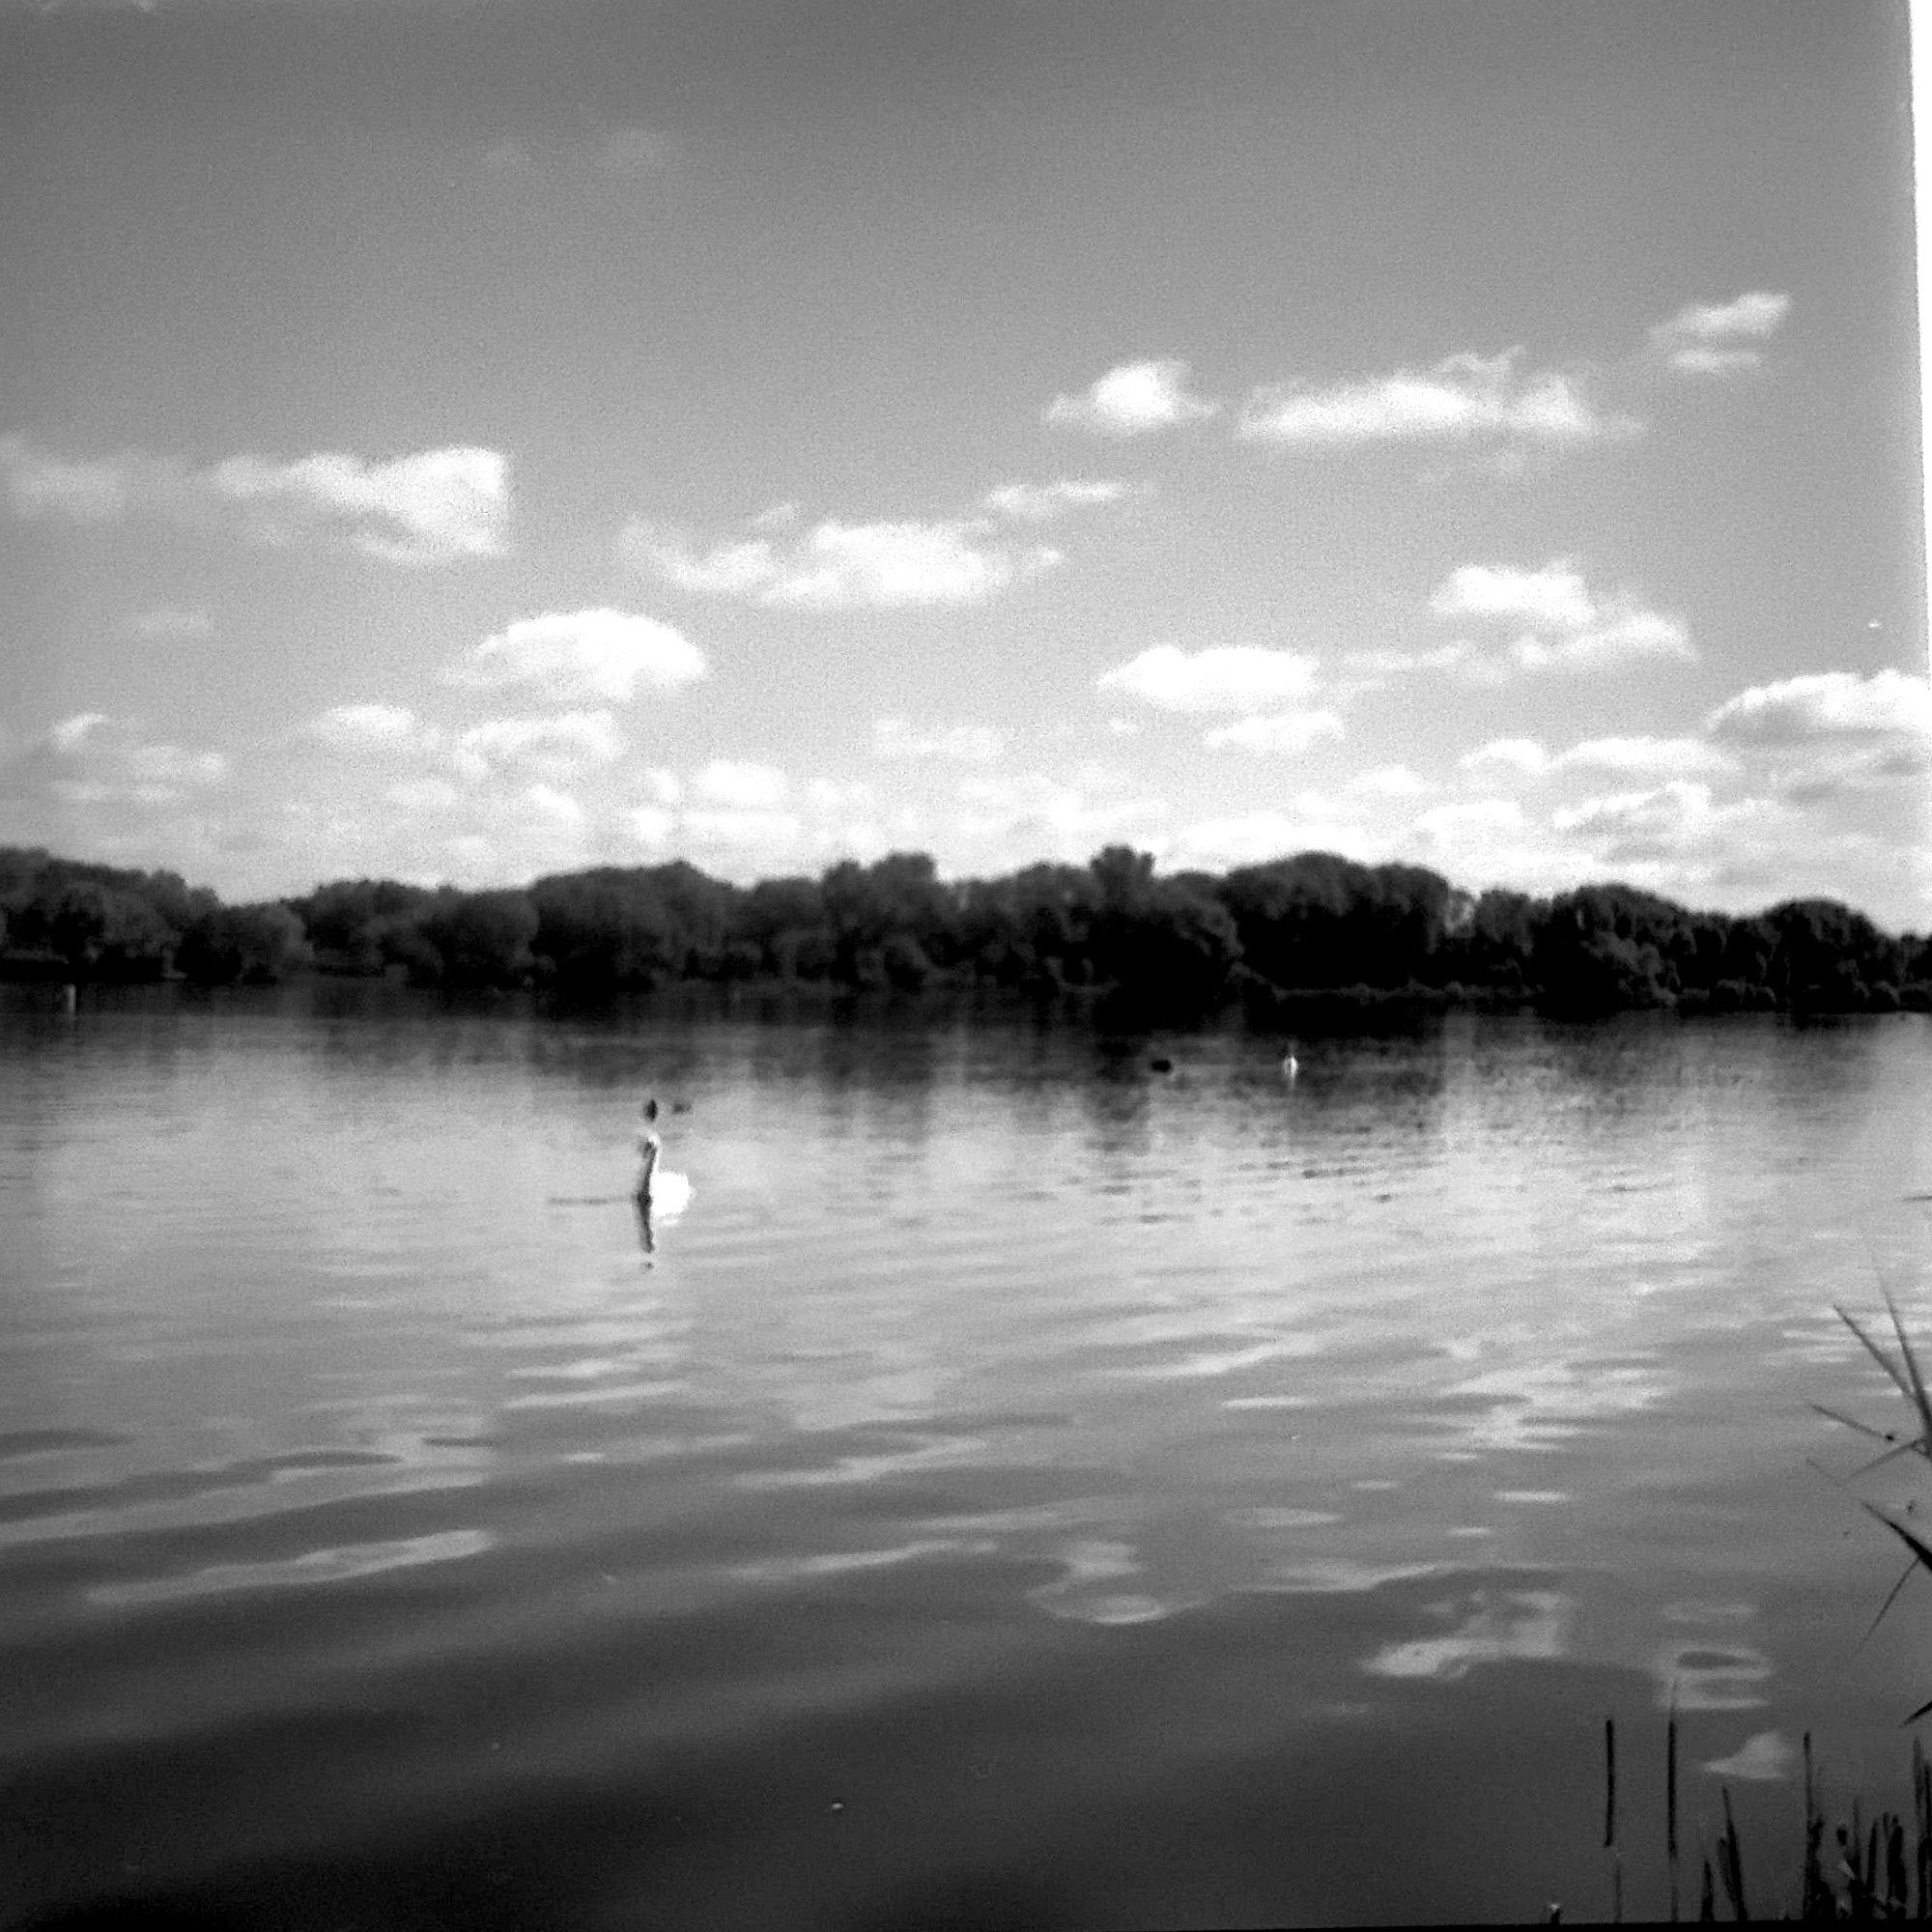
[0, 846, 1932, 1016]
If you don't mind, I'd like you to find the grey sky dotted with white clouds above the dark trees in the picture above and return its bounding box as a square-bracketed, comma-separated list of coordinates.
[0, 0, 1932, 931]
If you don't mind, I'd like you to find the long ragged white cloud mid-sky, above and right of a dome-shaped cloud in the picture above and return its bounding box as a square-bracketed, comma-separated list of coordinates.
[620, 506, 1061, 611]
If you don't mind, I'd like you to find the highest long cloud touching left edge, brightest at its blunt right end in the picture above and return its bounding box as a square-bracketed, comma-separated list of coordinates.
[0, 435, 510, 564]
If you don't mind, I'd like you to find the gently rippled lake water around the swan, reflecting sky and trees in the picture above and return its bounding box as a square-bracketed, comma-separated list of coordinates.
[0, 983, 1932, 1932]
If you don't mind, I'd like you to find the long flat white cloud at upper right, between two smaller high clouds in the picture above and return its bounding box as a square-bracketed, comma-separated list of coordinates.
[1236, 350, 1636, 448]
